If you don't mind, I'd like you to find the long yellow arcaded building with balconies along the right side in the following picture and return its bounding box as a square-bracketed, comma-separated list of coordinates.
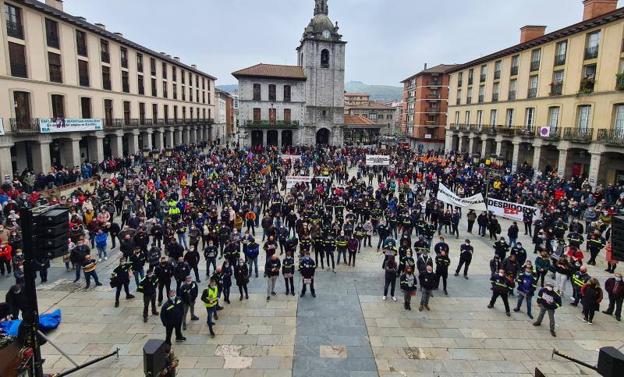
[446, 0, 624, 185]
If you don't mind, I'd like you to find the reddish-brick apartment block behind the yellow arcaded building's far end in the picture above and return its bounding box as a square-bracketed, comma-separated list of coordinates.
[401, 64, 455, 149]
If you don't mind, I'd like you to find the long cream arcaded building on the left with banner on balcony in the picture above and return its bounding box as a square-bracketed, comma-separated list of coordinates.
[0, 0, 215, 176]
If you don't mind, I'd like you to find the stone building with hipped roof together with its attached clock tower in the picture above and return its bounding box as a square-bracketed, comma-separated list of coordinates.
[233, 0, 346, 146]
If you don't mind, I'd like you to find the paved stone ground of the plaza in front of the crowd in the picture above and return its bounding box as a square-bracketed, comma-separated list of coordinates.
[0, 201, 624, 377]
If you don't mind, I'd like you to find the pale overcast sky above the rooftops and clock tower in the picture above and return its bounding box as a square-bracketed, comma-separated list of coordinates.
[64, 0, 624, 85]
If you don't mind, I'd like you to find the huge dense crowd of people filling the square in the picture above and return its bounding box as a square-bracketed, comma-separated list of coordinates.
[0, 140, 624, 343]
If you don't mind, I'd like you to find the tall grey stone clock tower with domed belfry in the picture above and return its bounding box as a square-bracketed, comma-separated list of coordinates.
[297, 0, 347, 146]
